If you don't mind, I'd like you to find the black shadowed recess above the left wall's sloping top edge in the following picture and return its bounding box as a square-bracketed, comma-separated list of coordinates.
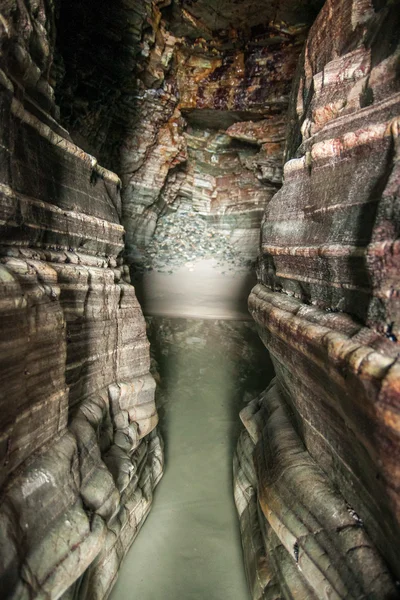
[55, 0, 160, 163]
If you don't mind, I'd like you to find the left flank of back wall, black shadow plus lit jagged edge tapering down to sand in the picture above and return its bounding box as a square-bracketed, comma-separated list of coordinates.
[53, 0, 186, 264]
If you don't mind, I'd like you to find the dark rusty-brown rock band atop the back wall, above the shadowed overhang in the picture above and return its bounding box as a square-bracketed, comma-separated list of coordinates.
[176, 24, 304, 119]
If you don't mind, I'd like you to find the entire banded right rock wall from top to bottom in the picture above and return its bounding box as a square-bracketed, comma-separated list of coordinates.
[236, 0, 400, 598]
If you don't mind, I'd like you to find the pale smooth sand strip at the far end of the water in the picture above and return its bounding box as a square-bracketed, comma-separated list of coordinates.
[133, 259, 256, 319]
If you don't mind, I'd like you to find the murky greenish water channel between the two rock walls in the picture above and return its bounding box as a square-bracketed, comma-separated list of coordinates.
[111, 319, 271, 600]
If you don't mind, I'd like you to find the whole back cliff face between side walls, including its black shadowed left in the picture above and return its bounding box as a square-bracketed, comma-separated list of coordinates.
[53, 2, 318, 272]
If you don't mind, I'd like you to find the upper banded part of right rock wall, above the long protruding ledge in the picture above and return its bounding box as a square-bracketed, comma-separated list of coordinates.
[261, 2, 400, 335]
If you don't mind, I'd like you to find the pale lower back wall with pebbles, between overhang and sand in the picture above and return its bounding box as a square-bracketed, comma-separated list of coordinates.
[139, 126, 283, 269]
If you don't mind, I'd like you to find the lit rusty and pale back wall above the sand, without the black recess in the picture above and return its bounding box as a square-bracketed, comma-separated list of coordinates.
[132, 15, 322, 276]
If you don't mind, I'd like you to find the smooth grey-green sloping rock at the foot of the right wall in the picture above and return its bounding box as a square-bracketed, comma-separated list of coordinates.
[236, 383, 397, 599]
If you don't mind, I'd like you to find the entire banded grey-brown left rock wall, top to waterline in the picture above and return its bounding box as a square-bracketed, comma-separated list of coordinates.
[0, 0, 163, 599]
